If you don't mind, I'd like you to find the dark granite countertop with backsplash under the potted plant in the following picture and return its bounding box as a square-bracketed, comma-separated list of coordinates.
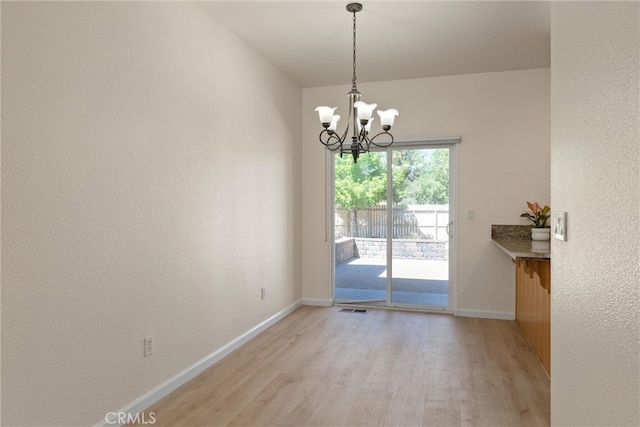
[491, 225, 551, 260]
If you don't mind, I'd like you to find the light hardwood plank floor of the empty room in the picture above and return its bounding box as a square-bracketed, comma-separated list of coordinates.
[145, 306, 549, 426]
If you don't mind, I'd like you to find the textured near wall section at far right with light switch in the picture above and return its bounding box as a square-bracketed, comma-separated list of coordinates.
[551, 2, 640, 426]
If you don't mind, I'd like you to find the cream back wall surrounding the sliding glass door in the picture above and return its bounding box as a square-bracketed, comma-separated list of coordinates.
[302, 69, 550, 317]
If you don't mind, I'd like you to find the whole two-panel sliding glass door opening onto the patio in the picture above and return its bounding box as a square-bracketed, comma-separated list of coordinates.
[333, 146, 453, 309]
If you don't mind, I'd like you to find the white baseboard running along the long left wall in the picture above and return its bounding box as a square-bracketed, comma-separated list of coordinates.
[96, 300, 303, 427]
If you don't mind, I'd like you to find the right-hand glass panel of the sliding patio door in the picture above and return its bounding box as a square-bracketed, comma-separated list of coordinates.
[388, 148, 450, 307]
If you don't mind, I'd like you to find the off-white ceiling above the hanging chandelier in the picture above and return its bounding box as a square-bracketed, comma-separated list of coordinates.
[200, 0, 550, 87]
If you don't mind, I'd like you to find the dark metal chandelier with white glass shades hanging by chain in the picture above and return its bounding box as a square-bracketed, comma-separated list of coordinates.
[316, 3, 398, 163]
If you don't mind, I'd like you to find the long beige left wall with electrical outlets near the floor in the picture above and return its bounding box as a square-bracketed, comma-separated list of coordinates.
[2, 2, 302, 425]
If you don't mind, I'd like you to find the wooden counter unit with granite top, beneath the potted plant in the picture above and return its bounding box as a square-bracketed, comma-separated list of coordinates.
[491, 225, 551, 376]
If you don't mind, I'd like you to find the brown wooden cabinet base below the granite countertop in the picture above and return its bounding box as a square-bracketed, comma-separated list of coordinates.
[514, 258, 551, 376]
